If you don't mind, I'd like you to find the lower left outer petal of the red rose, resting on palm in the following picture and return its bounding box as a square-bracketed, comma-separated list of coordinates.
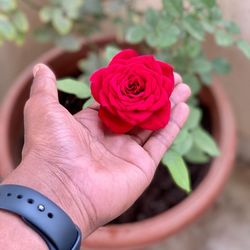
[98, 107, 133, 134]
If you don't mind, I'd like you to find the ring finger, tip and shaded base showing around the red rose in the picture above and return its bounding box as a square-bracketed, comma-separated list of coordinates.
[129, 83, 191, 146]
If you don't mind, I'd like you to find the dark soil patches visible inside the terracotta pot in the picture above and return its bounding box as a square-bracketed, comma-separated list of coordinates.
[59, 92, 211, 224]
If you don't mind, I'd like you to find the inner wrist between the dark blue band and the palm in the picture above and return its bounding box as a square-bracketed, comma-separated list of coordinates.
[3, 153, 93, 237]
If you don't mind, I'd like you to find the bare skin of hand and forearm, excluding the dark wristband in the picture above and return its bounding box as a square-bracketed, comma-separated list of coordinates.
[0, 64, 190, 250]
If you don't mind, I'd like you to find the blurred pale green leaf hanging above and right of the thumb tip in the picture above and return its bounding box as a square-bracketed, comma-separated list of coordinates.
[52, 9, 73, 35]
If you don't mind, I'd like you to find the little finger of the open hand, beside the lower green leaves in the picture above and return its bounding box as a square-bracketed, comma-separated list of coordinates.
[143, 102, 189, 166]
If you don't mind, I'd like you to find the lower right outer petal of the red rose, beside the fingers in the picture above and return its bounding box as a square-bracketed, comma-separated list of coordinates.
[138, 101, 171, 130]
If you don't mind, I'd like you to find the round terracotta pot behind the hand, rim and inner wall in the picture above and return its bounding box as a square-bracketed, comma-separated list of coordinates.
[0, 38, 236, 249]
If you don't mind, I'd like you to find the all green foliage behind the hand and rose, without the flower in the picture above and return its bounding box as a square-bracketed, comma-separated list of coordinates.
[0, 0, 250, 192]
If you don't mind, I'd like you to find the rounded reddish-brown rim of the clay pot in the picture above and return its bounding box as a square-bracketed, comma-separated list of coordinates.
[0, 37, 236, 249]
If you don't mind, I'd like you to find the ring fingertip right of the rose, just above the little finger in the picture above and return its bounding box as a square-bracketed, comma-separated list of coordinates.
[170, 83, 191, 108]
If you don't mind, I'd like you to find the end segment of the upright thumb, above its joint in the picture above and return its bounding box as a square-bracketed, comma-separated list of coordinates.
[30, 64, 58, 101]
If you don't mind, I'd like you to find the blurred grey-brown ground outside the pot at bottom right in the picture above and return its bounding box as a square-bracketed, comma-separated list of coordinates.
[145, 162, 250, 250]
